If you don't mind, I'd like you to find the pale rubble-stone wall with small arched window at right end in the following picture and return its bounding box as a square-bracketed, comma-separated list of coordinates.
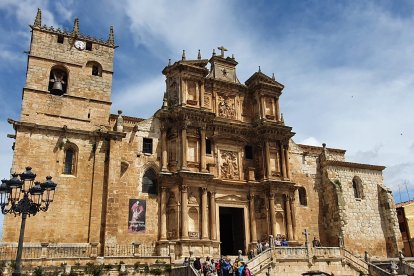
[324, 166, 388, 256]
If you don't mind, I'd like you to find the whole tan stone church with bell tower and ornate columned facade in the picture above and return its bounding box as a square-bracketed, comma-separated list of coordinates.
[3, 11, 401, 259]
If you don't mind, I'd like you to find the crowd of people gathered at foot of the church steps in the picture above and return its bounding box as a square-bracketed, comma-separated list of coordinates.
[188, 256, 252, 276]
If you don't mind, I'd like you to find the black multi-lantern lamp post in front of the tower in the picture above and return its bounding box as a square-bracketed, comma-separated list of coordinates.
[0, 167, 57, 276]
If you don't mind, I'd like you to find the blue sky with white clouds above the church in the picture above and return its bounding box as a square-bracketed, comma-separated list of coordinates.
[0, 0, 414, 237]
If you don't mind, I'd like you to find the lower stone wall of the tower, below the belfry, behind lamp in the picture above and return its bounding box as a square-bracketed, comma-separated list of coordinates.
[3, 128, 106, 243]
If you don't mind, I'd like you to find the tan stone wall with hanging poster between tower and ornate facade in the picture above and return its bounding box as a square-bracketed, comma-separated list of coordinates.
[105, 119, 160, 244]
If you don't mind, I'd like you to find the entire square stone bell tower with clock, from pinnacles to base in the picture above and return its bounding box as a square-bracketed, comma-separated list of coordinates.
[2, 9, 118, 244]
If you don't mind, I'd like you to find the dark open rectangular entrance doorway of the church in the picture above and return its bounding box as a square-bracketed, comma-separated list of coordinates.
[219, 207, 245, 256]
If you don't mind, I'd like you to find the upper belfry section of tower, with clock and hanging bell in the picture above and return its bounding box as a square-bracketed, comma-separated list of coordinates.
[20, 9, 116, 130]
